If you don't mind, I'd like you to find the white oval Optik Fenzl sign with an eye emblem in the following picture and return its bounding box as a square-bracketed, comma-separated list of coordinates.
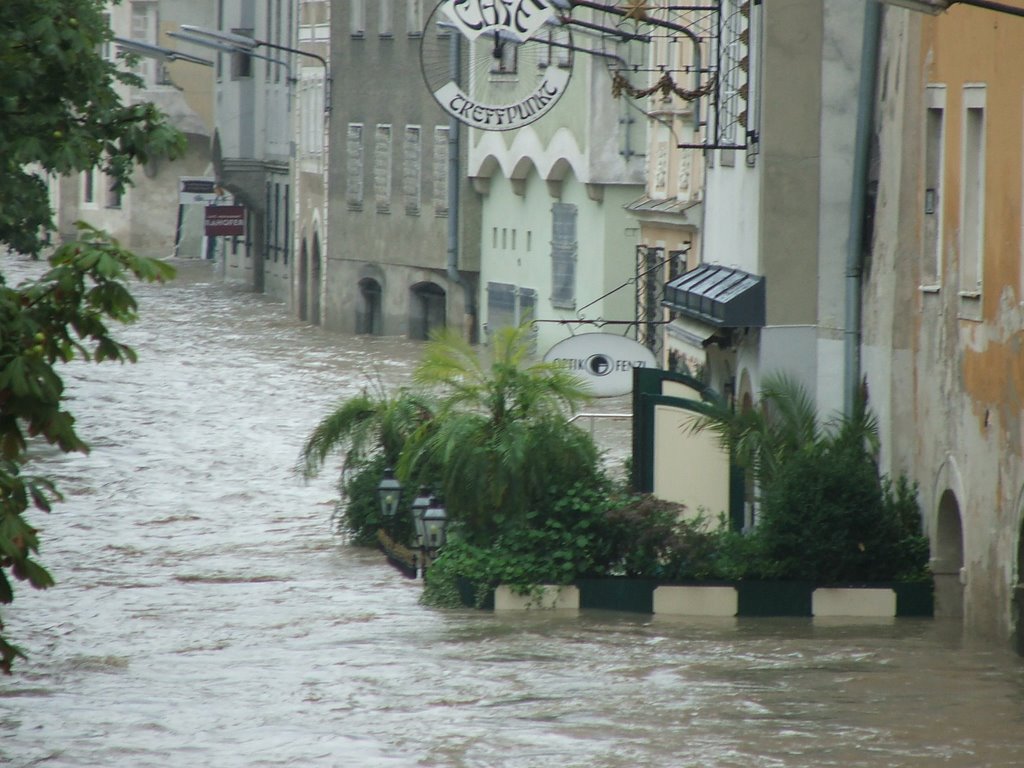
[544, 334, 658, 397]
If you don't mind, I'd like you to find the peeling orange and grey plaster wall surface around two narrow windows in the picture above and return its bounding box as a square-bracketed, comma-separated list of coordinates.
[865, 6, 1024, 639]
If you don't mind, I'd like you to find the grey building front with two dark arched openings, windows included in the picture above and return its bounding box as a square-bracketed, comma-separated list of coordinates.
[322, 0, 480, 339]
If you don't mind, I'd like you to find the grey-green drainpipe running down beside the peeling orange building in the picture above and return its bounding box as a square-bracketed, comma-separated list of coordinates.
[843, 0, 882, 416]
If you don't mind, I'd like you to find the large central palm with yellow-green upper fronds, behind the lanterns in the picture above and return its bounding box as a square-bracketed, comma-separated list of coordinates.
[399, 324, 598, 541]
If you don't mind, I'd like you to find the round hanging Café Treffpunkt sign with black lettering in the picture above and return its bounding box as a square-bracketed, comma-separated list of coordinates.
[420, 0, 572, 131]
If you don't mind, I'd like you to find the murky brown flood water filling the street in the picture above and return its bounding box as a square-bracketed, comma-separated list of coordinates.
[0, 258, 1024, 768]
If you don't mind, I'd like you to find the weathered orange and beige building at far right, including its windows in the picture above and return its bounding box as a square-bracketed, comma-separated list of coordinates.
[861, 0, 1024, 641]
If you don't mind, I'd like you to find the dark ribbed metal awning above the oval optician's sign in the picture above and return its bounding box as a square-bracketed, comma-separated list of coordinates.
[663, 264, 765, 328]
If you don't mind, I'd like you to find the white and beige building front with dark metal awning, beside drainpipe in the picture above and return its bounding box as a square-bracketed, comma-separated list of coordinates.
[666, 0, 864, 415]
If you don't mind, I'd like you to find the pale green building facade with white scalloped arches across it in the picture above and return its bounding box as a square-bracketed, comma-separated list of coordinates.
[469, 8, 646, 354]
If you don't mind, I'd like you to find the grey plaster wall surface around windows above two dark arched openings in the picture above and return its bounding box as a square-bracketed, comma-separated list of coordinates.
[323, 3, 480, 336]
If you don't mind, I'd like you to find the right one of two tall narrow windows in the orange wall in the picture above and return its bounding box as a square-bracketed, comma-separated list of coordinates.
[959, 86, 985, 297]
